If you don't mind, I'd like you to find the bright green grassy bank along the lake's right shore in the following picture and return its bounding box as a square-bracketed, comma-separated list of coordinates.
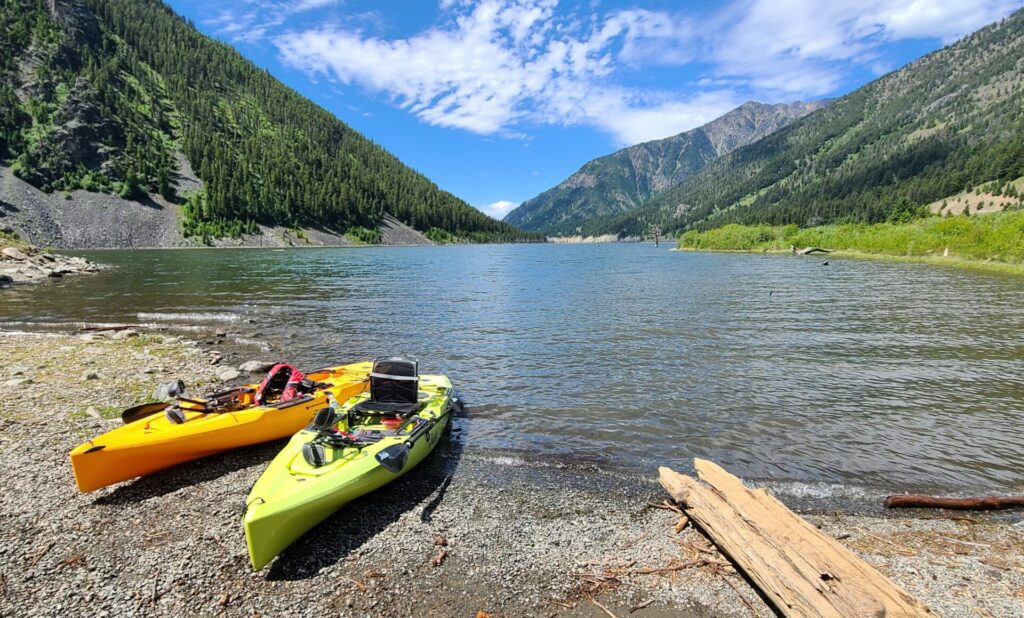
[679, 212, 1024, 273]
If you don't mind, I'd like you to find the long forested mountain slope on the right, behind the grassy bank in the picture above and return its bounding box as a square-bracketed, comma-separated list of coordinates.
[582, 10, 1024, 235]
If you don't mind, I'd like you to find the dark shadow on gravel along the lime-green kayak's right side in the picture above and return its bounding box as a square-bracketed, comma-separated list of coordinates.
[266, 399, 467, 581]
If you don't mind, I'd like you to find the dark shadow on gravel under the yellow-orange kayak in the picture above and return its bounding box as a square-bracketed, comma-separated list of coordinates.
[93, 439, 288, 504]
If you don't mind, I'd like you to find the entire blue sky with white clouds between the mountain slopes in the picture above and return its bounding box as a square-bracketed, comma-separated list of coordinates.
[163, 0, 1024, 218]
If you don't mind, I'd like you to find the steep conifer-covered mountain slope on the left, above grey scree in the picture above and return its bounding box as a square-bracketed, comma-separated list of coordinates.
[0, 0, 539, 240]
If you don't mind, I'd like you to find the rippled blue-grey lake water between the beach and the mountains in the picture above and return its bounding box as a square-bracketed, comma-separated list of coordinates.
[0, 245, 1024, 492]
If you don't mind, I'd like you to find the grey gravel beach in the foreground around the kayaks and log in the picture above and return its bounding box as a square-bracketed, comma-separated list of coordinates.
[0, 329, 1024, 617]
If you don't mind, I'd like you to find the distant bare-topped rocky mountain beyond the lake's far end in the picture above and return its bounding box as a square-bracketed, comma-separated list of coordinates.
[505, 101, 827, 235]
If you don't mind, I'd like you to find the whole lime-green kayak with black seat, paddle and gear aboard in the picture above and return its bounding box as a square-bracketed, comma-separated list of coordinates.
[244, 358, 453, 570]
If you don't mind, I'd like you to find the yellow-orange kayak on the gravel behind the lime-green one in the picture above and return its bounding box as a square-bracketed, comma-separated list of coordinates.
[71, 362, 372, 492]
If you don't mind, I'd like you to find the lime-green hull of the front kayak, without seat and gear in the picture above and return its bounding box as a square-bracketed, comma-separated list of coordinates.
[243, 376, 451, 570]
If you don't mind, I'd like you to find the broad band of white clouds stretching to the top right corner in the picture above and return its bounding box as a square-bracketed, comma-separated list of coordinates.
[268, 0, 1022, 144]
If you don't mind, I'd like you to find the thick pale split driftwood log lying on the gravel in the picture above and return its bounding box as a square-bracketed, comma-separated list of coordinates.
[659, 459, 934, 617]
